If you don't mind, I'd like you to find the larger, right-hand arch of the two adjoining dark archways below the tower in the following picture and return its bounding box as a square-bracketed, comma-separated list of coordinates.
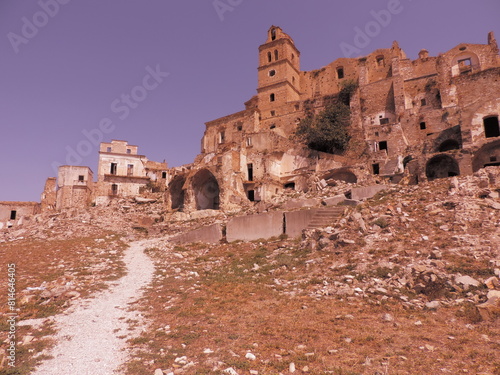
[191, 169, 220, 210]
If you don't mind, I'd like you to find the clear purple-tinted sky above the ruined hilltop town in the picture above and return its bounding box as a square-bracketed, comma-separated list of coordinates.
[0, 0, 500, 201]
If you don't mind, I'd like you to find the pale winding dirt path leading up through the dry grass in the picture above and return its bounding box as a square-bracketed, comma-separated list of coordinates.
[32, 241, 154, 375]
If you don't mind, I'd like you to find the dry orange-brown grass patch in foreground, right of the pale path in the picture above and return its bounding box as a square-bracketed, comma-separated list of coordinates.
[128, 241, 500, 375]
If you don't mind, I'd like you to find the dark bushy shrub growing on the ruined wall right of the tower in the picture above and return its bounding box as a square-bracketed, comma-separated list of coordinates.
[295, 81, 357, 153]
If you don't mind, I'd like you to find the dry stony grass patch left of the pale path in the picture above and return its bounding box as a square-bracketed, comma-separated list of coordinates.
[0, 232, 126, 375]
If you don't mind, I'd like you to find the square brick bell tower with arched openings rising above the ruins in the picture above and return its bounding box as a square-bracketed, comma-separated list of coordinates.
[257, 26, 300, 118]
